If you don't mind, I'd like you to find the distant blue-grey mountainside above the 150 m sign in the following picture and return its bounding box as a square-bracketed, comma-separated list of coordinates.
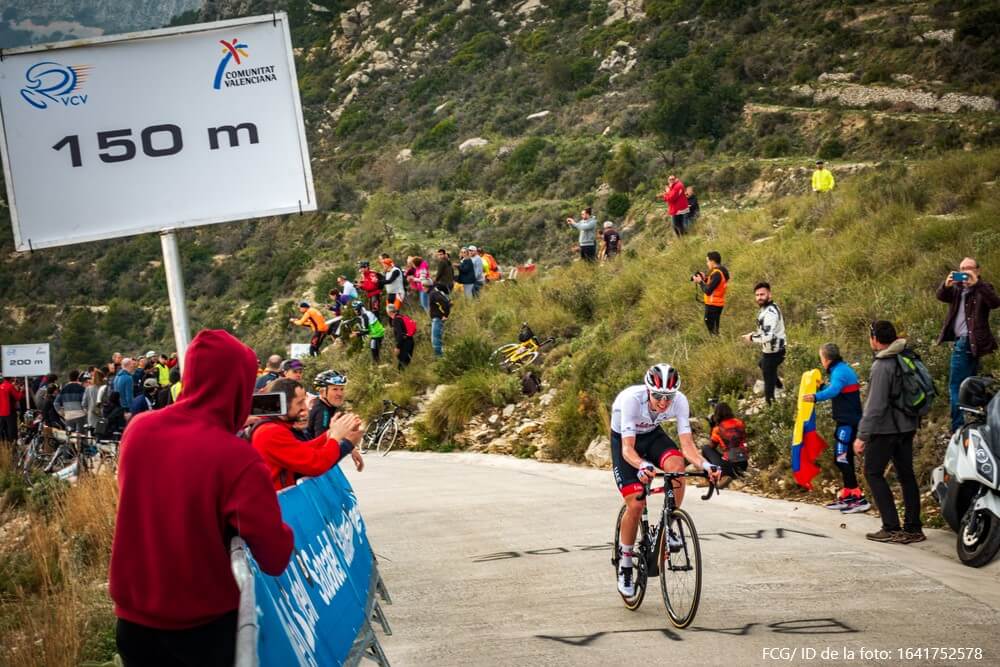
[3, 0, 203, 34]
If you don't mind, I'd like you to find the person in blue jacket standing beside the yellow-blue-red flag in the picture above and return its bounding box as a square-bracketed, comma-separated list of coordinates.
[802, 343, 871, 514]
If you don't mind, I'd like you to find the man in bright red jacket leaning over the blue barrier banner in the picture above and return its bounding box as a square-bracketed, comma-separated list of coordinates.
[250, 378, 365, 491]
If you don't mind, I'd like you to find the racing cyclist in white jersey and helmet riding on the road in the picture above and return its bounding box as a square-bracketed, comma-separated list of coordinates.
[611, 364, 721, 597]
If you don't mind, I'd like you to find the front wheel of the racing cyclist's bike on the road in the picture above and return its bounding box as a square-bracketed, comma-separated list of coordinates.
[657, 509, 701, 628]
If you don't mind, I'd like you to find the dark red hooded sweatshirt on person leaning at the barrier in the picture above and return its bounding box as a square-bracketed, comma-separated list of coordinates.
[110, 331, 294, 630]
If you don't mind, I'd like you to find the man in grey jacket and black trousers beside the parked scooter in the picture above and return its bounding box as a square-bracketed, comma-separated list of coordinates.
[854, 320, 927, 544]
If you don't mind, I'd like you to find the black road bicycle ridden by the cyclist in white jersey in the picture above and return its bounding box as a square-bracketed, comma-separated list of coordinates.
[611, 471, 717, 628]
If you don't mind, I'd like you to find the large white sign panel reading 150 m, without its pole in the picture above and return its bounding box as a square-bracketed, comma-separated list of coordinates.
[0, 13, 316, 250]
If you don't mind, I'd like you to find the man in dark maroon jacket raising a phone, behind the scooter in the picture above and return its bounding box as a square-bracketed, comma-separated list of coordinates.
[937, 257, 1000, 431]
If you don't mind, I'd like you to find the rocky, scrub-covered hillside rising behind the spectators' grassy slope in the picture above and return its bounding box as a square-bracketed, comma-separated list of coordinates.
[0, 0, 1000, 368]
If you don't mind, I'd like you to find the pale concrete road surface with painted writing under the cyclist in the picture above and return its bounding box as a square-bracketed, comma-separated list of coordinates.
[348, 452, 1000, 667]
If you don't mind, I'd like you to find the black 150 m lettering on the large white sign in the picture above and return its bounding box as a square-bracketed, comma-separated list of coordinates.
[52, 123, 260, 167]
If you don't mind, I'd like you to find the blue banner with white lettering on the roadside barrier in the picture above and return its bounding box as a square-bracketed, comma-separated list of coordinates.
[247, 467, 375, 667]
